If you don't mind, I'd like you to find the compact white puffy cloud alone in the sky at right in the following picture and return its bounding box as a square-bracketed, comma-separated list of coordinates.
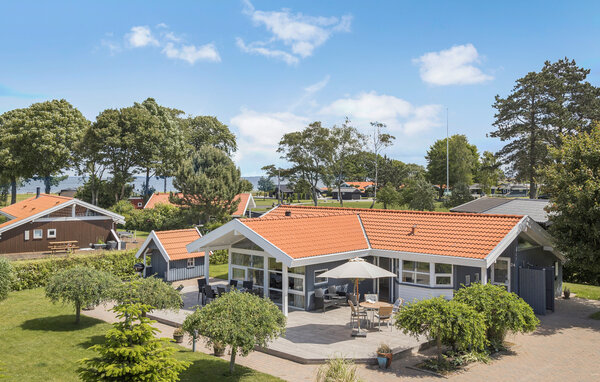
[413, 44, 494, 85]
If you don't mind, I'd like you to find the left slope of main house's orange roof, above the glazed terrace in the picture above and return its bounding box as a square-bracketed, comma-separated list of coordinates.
[241, 214, 369, 259]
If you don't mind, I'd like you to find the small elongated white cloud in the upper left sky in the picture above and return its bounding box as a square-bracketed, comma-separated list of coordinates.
[100, 23, 221, 65]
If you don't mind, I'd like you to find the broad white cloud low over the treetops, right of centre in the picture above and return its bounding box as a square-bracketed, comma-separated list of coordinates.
[319, 91, 442, 136]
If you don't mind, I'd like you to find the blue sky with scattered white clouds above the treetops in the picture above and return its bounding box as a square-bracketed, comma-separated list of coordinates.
[0, 0, 600, 176]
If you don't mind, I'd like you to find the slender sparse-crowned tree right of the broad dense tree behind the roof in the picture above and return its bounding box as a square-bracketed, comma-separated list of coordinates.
[328, 118, 365, 207]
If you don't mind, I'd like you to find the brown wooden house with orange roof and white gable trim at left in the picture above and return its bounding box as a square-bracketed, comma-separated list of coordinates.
[0, 194, 125, 253]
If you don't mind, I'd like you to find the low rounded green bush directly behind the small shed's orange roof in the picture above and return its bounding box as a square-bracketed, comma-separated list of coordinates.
[125, 203, 192, 232]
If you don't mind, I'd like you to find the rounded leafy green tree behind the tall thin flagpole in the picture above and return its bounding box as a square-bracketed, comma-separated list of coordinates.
[425, 134, 479, 196]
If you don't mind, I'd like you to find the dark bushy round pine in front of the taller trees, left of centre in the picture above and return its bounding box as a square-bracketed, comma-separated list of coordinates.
[171, 146, 242, 223]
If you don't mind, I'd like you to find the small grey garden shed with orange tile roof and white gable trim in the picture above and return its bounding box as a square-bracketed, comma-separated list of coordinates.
[135, 228, 205, 281]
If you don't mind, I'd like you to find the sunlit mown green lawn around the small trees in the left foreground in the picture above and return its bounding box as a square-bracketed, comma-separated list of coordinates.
[0, 289, 280, 382]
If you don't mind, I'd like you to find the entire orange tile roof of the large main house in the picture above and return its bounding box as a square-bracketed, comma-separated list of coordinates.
[244, 206, 523, 259]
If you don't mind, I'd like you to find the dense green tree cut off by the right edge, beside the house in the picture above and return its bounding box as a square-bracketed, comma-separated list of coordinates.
[542, 127, 600, 285]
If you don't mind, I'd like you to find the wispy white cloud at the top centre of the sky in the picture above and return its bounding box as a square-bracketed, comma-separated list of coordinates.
[237, 0, 352, 65]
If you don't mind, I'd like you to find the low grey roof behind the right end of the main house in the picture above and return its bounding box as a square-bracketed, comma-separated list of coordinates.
[450, 197, 550, 228]
